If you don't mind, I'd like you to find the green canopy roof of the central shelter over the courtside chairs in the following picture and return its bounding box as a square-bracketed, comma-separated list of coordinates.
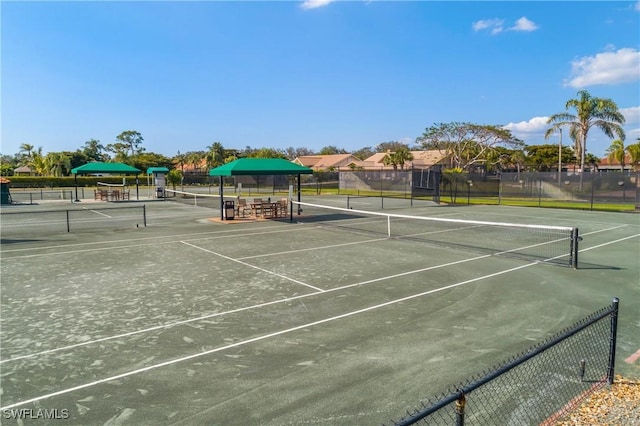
[209, 158, 313, 176]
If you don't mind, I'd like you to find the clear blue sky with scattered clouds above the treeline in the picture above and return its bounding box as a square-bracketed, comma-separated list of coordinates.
[0, 0, 640, 156]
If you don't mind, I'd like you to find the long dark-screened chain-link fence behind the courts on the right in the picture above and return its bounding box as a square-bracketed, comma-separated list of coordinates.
[332, 166, 640, 210]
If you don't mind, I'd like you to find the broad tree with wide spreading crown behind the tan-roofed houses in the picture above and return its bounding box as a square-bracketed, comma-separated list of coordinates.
[417, 122, 524, 169]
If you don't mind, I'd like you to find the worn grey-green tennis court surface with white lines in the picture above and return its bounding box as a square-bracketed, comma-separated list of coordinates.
[0, 196, 640, 425]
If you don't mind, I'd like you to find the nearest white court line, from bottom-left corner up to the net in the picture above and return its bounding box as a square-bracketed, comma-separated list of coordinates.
[0, 263, 537, 410]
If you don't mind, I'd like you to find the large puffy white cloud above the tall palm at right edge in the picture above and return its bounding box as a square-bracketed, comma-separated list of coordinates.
[564, 47, 640, 88]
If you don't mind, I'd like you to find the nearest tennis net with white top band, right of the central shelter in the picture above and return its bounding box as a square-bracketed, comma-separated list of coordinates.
[291, 201, 580, 268]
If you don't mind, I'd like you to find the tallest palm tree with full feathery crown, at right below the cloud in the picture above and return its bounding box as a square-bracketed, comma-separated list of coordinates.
[547, 90, 625, 184]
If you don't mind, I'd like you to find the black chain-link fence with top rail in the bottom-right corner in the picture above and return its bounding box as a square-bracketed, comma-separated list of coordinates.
[393, 298, 619, 426]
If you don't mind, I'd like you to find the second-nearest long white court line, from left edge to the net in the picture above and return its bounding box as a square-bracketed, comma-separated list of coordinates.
[0, 255, 489, 364]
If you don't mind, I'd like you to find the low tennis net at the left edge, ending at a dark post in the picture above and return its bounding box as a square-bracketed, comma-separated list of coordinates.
[0, 204, 147, 240]
